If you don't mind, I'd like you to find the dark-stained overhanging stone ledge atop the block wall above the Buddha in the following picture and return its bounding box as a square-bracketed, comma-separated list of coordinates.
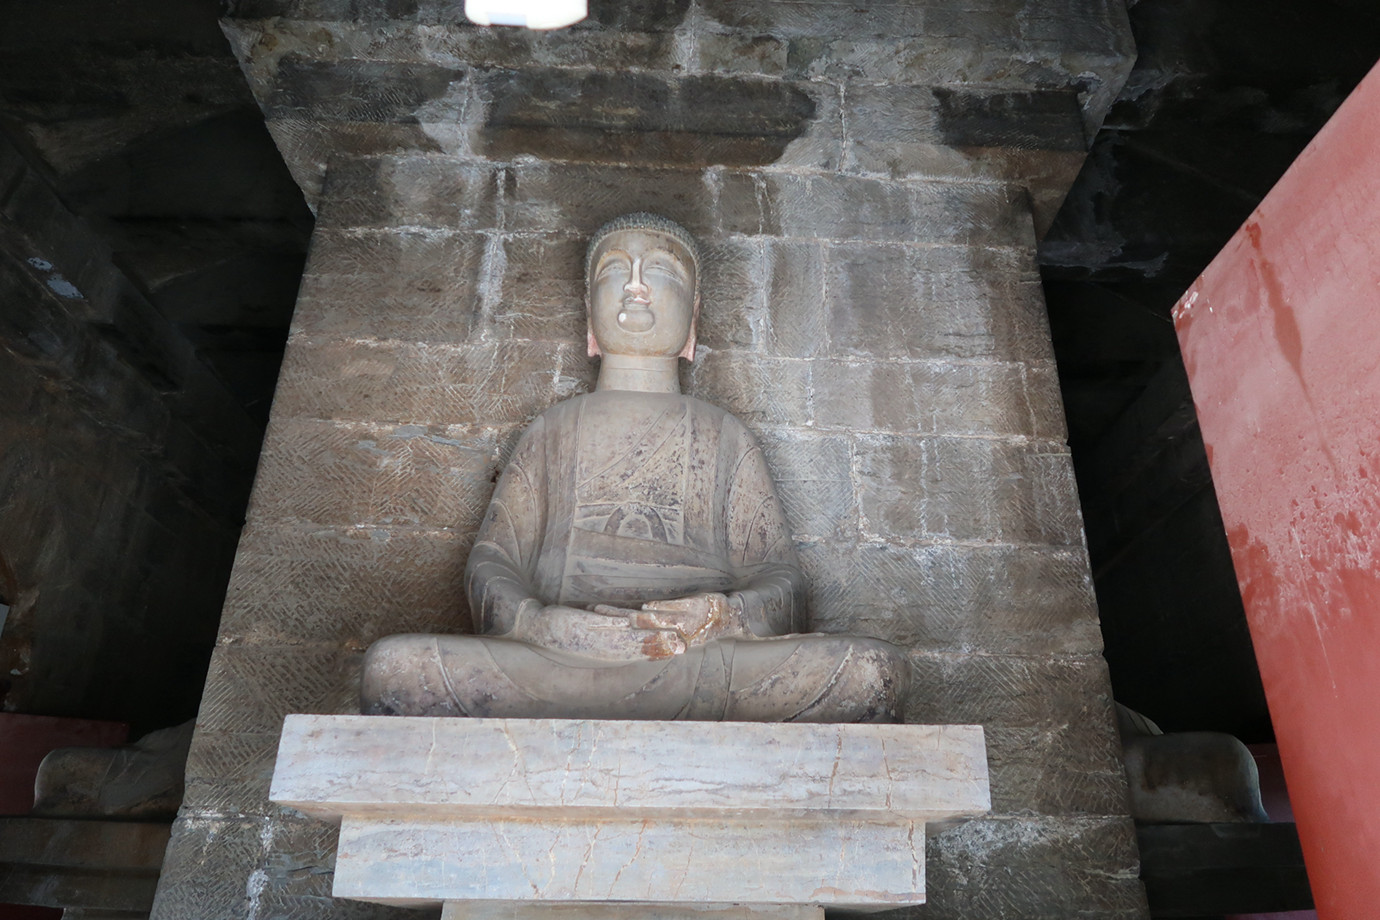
[222, 0, 1134, 230]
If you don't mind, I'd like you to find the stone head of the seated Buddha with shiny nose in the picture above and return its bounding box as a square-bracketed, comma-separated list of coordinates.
[585, 212, 700, 361]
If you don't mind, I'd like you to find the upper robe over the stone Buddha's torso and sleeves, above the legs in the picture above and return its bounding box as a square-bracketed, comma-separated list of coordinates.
[465, 390, 805, 645]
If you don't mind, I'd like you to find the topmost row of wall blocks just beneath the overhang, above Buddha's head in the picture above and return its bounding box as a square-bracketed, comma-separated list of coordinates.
[307, 156, 1034, 247]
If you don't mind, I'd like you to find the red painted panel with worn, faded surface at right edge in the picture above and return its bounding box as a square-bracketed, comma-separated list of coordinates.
[1174, 61, 1380, 920]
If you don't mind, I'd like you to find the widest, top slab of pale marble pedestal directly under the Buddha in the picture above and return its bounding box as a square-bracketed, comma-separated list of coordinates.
[272, 714, 987, 821]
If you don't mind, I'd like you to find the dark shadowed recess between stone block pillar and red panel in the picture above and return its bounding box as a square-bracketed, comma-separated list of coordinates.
[1041, 0, 1380, 742]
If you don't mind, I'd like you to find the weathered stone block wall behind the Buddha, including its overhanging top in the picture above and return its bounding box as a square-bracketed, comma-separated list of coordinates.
[153, 0, 1145, 920]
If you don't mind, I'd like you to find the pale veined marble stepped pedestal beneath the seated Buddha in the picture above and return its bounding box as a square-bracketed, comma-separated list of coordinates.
[270, 716, 989, 920]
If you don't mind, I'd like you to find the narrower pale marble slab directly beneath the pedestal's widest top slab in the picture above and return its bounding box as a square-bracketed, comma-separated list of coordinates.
[333, 817, 925, 910]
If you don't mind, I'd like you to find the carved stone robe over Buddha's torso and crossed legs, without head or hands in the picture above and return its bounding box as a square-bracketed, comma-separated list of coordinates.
[363, 390, 907, 721]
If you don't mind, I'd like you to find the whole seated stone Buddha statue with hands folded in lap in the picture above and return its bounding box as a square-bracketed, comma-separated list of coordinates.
[362, 214, 909, 721]
